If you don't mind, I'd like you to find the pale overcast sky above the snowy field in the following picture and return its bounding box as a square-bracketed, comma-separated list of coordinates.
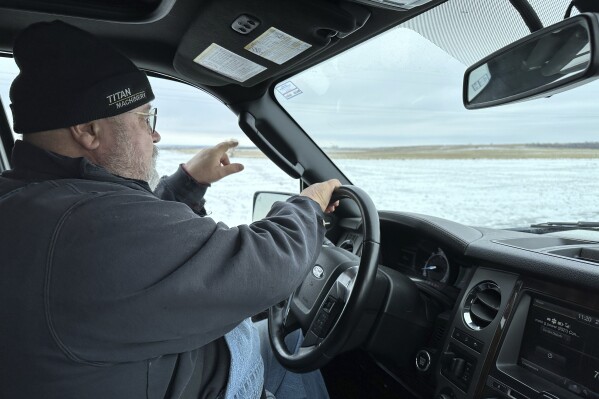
[0, 28, 599, 147]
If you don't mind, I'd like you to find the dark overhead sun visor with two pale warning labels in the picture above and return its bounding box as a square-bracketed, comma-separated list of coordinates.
[173, 0, 370, 87]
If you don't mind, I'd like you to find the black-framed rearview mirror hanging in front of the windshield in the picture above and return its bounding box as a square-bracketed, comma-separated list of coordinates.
[463, 13, 599, 109]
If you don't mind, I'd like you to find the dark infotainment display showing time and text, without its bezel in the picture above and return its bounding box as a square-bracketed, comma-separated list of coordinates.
[519, 298, 599, 398]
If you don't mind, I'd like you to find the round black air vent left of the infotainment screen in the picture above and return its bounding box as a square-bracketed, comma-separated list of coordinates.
[464, 281, 501, 330]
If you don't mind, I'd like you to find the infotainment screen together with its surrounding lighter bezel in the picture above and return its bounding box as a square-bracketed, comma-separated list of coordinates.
[487, 291, 599, 399]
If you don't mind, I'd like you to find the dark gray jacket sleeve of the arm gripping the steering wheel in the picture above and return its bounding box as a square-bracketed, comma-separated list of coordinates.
[46, 186, 325, 362]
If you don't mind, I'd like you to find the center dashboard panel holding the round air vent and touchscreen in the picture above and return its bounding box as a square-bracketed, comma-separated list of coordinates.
[436, 268, 599, 399]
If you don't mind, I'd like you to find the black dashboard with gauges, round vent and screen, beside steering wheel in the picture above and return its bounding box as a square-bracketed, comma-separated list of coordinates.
[332, 212, 599, 399]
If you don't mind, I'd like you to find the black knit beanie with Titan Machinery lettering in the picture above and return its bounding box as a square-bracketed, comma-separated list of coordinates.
[10, 21, 154, 134]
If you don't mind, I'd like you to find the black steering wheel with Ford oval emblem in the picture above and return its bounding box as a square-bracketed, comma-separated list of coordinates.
[268, 185, 380, 372]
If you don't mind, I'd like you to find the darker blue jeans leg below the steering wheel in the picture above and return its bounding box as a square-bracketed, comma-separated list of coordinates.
[254, 320, 329, 399]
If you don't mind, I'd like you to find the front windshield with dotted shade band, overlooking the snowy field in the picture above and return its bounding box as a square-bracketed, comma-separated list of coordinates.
[274, 0, 599, 227]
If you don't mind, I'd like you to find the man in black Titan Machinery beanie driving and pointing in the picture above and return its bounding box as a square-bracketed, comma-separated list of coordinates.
[0, 22, 339, 399]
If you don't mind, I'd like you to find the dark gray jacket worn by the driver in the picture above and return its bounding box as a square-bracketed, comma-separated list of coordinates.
[0, 142, 324, 398]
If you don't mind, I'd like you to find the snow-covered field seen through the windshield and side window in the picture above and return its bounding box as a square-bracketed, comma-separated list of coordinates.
[158, 150, 599, 227]
